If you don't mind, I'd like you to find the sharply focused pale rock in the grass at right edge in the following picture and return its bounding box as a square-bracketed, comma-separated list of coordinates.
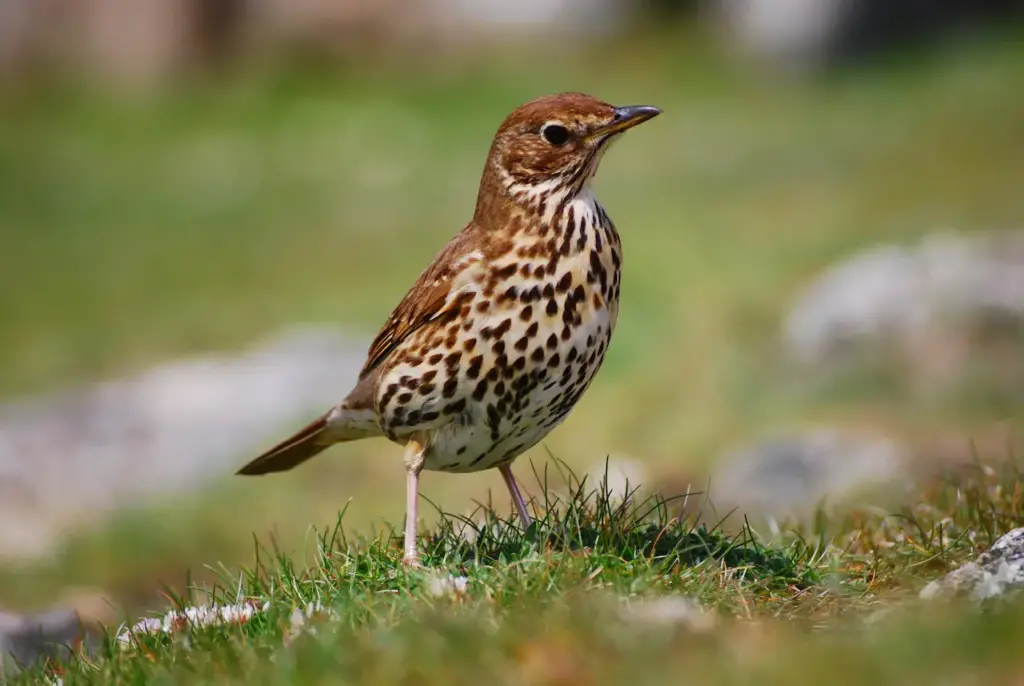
[921, 528, 1024, 603]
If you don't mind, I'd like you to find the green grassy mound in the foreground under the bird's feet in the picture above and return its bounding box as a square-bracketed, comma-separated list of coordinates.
[11, 456, 1024, 685]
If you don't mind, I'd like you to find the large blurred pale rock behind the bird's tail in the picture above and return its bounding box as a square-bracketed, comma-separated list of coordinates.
[0, 328, 366, 558]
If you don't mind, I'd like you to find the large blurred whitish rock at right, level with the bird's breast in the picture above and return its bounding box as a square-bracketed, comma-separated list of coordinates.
[784, 232, 1024, 362]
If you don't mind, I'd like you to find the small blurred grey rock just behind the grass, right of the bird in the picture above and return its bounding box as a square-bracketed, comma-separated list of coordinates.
[709, 429, 909, 519]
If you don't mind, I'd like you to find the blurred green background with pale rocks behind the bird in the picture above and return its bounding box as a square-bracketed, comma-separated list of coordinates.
[0, 0, 1024, 622]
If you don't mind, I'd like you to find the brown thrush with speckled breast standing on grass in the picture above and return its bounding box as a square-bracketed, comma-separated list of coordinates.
[238, 92, 662, 567]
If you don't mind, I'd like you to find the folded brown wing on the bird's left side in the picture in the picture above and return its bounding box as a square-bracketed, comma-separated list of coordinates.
[359, 227, 477, 379]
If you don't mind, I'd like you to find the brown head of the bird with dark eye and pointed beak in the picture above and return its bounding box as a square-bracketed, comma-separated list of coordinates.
[481, 93, 662, 215]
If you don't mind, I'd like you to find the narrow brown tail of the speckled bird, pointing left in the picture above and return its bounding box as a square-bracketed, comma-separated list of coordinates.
[238, 406, 380, 475]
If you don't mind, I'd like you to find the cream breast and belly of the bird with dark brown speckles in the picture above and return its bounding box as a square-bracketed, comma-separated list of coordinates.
[377, 192, 622, 472]
